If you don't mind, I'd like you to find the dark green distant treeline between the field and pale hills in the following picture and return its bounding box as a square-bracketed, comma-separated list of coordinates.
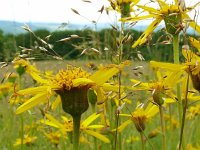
[0, 28, 197, 61]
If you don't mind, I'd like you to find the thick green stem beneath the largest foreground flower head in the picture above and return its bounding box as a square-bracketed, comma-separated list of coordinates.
[72, 115, 81, 150]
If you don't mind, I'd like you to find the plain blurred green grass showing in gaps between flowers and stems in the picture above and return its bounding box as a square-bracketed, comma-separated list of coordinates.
[0, 61, 200, 150]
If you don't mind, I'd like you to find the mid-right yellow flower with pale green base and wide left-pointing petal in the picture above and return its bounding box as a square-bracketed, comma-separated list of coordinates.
[131, 70, 183, 106]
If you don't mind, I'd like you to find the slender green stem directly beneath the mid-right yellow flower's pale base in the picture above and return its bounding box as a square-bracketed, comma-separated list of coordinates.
[159, 106, 167, 150]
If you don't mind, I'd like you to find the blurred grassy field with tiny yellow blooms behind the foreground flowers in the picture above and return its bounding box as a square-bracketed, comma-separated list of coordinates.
[0, 61, 200, 150]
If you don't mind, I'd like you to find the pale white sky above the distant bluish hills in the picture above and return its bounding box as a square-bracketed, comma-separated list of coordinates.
[0, 0, 200, 23]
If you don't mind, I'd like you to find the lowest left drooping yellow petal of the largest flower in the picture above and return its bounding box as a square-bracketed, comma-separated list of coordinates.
[16, 93, 48, 114]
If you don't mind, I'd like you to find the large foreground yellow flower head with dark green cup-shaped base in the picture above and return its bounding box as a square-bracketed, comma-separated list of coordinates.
[16, 65, 123, 115]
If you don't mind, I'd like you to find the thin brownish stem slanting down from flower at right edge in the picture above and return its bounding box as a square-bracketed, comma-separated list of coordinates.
[178, 74, 189, 150]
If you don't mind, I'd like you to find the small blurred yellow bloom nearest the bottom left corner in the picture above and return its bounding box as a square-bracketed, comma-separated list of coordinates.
[14, 135, 37, 146]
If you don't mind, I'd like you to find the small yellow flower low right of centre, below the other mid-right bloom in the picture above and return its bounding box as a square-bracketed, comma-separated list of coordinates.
[112, 103, 159, 132]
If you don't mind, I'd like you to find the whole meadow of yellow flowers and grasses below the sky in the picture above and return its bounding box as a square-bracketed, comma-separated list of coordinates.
[0, 0, 200, 150]
